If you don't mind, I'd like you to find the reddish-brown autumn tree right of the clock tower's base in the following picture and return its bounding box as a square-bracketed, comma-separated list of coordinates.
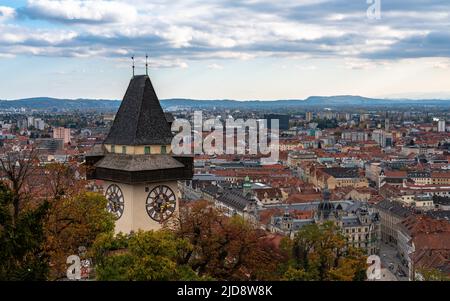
[168, 201, 282, 280]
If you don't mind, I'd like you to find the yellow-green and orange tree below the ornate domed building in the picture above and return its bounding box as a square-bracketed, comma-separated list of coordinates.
[284, 222, 367, 281]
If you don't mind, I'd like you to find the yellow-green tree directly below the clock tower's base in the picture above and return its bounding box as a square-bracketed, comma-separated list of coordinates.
[91, 230, 201, 281]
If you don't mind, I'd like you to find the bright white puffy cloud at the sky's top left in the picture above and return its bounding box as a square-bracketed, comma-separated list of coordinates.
[21, 0, 137, 23]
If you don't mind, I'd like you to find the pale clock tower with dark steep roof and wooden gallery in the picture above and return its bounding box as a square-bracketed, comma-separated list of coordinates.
[86, 75, 193, 233]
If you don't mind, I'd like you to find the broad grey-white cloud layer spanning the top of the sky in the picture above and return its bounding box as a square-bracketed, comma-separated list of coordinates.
[0, 0, 450, 63]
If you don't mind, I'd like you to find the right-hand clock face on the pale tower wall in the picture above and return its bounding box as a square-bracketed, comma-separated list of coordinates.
[145, 185, 177, 223]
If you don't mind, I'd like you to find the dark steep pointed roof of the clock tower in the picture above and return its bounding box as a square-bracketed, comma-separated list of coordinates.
[104, 75, 172, 145]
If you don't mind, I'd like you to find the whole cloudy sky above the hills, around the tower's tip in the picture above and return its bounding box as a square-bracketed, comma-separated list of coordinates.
[0, 0, 450, 100]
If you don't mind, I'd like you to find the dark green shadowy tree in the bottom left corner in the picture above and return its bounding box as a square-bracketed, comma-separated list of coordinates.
[0, 183, 49, 280]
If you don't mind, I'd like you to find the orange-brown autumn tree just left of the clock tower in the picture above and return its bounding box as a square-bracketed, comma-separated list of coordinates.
[24, 162, 114, 279]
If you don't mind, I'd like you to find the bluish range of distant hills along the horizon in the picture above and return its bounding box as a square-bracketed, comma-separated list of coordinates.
[0, 95, 450, 111]
